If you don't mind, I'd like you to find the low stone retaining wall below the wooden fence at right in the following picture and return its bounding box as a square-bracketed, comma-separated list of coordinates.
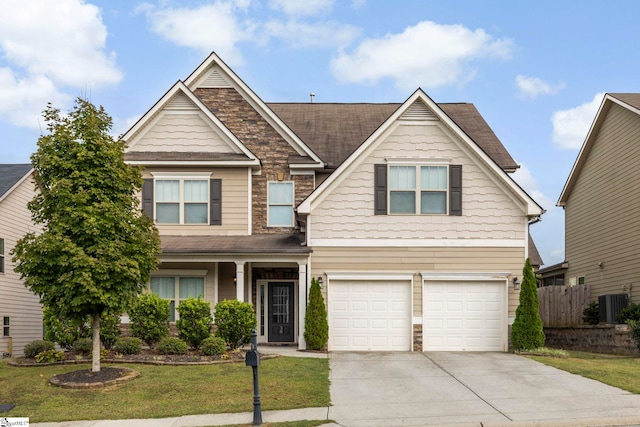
[544, 325, 640, 354]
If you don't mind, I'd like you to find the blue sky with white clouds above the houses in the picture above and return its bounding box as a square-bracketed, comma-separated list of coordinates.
[0, 0, 640, 266]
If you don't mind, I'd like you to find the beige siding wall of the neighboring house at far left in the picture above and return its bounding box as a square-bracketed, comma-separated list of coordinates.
[0, 179, 42, 357]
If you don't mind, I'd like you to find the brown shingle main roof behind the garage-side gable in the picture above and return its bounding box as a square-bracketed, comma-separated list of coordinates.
[267, 103, 517, 169]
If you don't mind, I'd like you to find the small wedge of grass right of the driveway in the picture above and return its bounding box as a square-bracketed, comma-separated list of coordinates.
[527, 351, 640, 394]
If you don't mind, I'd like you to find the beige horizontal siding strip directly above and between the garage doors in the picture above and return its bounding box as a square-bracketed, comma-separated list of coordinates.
[311, 247, 524, 317]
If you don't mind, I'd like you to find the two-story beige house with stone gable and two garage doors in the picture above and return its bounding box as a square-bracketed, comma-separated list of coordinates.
[123, 54, 543, 351]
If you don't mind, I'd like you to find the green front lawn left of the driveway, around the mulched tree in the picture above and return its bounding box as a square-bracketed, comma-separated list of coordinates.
[0, 357, 330, 423]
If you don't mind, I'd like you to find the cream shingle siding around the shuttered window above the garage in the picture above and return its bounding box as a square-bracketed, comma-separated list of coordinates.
[311, 121, 527, 242]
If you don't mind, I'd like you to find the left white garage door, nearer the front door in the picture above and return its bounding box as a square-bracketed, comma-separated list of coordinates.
[328, 280, 412, 351]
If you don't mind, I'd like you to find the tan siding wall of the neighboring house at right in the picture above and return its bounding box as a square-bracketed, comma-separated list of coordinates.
[565, 104, 640, 303]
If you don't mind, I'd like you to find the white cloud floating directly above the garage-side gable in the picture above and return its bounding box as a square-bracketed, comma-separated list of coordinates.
[331, 21, 511, 90]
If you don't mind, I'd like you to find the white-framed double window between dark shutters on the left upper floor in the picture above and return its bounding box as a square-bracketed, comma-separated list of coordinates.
[155, 179, 209, 224]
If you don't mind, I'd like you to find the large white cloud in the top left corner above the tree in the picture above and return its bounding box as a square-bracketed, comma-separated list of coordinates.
[0, 0, 122, 128]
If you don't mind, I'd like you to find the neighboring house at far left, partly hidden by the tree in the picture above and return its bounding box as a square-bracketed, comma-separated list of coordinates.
[0, 164, 42, 357]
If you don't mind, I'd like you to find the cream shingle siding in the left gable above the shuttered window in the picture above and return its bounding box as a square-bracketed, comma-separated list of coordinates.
[134, 111, 234, 153]
